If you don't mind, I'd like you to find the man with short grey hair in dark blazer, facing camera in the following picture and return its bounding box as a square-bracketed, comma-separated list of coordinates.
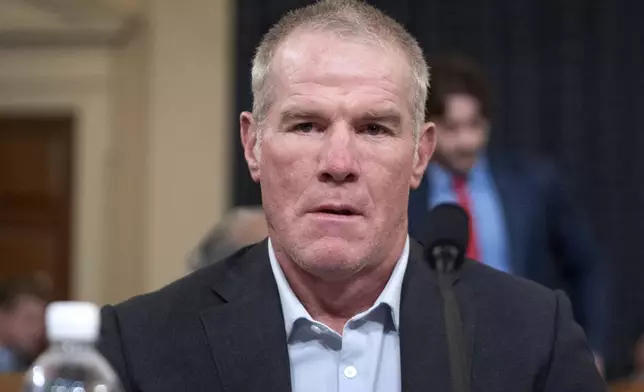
[100, 0, 604, 392]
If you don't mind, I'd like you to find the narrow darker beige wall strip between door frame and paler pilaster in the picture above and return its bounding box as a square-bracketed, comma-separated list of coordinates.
[103, 16, 152, 302]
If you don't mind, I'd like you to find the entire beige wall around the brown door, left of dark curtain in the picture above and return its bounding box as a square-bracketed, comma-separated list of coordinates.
[0, 0, 234, 303]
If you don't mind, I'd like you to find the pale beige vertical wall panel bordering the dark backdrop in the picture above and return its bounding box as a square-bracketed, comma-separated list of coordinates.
[144, 0, 234, 296]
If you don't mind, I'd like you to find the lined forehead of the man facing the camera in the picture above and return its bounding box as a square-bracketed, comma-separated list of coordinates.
[271, 31, 411, 111]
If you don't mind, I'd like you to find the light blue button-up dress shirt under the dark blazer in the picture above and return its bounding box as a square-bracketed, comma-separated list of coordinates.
[268, 237, 409, 392]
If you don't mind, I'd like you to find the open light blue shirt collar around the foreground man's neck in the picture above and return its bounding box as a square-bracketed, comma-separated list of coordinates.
[268, 236, 409, 337]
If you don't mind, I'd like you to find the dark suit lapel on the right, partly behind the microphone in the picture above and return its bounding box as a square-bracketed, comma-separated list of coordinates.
[400, 243, 476, 392]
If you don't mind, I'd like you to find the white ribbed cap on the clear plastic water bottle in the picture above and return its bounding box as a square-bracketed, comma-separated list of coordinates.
[46, 302, 101, 342]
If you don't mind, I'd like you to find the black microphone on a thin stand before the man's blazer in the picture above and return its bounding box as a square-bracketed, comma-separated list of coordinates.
[424, 203, 470, 392]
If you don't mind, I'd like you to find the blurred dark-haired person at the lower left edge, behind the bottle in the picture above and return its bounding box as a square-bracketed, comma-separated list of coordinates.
[0, 282, 46, 373]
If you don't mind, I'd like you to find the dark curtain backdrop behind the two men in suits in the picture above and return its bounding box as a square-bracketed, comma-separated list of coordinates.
[231, 0, 644, 379]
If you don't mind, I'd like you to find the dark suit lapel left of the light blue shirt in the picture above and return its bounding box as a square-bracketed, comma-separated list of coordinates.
[201, 241, 291, 392]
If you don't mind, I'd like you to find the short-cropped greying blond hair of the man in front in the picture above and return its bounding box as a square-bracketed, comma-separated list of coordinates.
[251, 0, 429, 139]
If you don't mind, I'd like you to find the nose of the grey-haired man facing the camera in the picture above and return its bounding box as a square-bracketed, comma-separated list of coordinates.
[318, 125, 359, 184]
